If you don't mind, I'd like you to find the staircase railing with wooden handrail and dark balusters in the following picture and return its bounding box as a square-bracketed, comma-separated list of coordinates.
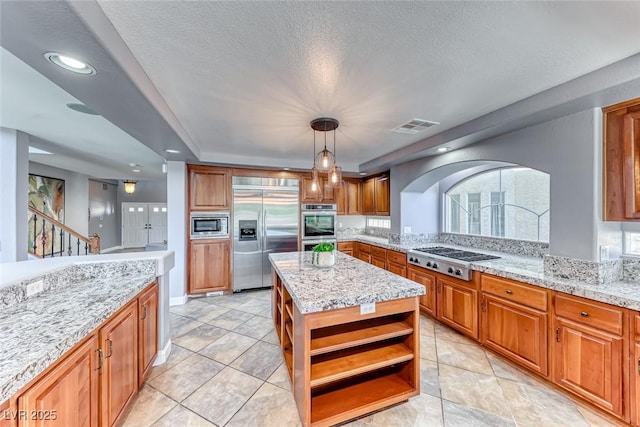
[28, 206, 100, 258]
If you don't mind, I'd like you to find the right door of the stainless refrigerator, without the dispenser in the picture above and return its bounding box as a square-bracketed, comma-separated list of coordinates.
[262, 190, 299, 287]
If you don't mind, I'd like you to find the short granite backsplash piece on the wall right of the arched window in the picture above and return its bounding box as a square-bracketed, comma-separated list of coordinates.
[544, 255, 623, 284]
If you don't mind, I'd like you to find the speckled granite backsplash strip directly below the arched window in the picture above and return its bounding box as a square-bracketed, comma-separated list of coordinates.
[439, 233, 549, 258]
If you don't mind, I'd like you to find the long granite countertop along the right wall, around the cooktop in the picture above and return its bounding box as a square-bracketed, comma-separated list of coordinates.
[338, 235, 640, 310]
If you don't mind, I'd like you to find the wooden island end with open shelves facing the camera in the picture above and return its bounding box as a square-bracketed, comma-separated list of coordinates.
[292, 297, 420, 426]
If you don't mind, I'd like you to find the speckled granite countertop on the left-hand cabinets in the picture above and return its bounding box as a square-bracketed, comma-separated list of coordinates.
[0, 273, 156, 403]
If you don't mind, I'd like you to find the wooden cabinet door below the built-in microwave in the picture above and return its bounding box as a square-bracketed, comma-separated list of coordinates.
[188, 240, 231, 294]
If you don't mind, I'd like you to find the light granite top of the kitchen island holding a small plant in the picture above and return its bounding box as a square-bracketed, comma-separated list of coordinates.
[269, 252, 425, 314]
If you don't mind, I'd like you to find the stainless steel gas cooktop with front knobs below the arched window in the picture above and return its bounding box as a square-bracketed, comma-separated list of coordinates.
[407, 246, 500, 280]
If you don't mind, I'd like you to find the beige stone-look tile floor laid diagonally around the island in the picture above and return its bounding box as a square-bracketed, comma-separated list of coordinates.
[122, 290, 614, 427]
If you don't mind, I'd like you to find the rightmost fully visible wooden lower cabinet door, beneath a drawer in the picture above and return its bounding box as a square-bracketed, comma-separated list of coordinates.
[553, 317, 623, 415]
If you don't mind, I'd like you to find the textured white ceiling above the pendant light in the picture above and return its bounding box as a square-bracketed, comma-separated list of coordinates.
[99, 1, 640, 170]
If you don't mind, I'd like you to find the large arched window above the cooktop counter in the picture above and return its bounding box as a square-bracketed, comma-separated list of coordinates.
[444, 167, 550, 242]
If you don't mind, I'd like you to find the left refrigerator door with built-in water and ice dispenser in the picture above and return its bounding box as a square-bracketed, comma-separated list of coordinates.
[233, 189, 263, 291]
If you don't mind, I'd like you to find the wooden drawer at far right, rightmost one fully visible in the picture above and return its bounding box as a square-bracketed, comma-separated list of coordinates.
[555, 295, 624, 336]
